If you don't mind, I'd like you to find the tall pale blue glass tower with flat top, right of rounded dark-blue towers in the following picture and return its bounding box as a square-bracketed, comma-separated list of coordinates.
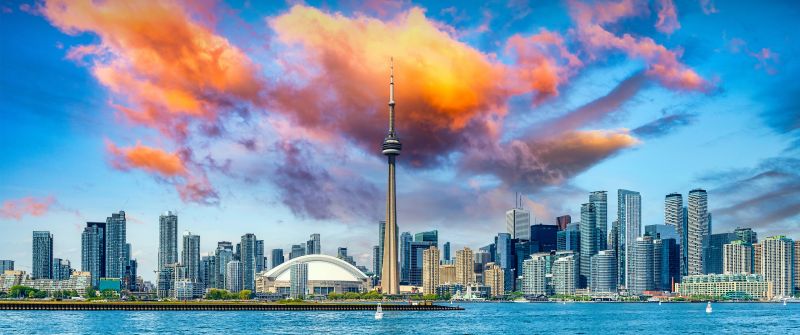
[620, 190, 642, 288]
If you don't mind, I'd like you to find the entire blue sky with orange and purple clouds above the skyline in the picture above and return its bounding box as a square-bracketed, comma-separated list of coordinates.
[0, 0, 800, 280]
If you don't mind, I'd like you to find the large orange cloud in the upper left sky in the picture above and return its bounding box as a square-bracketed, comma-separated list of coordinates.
[42, 0, 264, 138]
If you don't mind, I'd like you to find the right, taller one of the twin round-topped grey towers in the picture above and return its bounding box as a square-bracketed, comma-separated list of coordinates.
[686, 189, 708, 275]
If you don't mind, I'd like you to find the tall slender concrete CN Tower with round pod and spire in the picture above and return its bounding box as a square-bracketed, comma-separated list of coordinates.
[381, 61, 403, 294]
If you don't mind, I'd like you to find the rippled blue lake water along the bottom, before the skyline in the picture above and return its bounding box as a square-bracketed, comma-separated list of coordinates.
[0, 303, 800, 335]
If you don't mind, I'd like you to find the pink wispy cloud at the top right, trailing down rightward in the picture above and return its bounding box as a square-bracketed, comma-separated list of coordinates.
[569, 0, 711, 91]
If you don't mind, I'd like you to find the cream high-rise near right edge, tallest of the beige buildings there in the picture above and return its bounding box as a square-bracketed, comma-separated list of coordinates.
[761, 236, 794, 297]
